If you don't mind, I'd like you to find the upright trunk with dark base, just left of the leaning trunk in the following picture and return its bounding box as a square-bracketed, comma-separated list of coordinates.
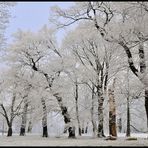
[41, 98, 48, 137]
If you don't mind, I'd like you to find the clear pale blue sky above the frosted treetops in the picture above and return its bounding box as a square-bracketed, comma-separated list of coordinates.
[6, 1, 73, 42]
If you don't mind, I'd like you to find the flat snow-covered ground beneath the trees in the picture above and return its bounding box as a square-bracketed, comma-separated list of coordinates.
[0, 134, 148, 146]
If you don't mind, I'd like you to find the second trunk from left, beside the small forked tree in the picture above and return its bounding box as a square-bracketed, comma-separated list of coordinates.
[20, 100, 28, 136]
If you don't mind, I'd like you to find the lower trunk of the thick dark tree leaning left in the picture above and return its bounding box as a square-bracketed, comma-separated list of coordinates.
[53, 93, 76, 138]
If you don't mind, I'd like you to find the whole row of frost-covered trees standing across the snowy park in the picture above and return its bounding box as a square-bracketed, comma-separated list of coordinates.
[0, 2, 148, 138]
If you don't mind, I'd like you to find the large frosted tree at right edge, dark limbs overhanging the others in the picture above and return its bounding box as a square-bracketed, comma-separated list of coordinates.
[51, 1, 148, 131]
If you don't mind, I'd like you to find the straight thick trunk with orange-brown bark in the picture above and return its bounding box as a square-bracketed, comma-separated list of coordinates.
[108, 79, 117, 137]
